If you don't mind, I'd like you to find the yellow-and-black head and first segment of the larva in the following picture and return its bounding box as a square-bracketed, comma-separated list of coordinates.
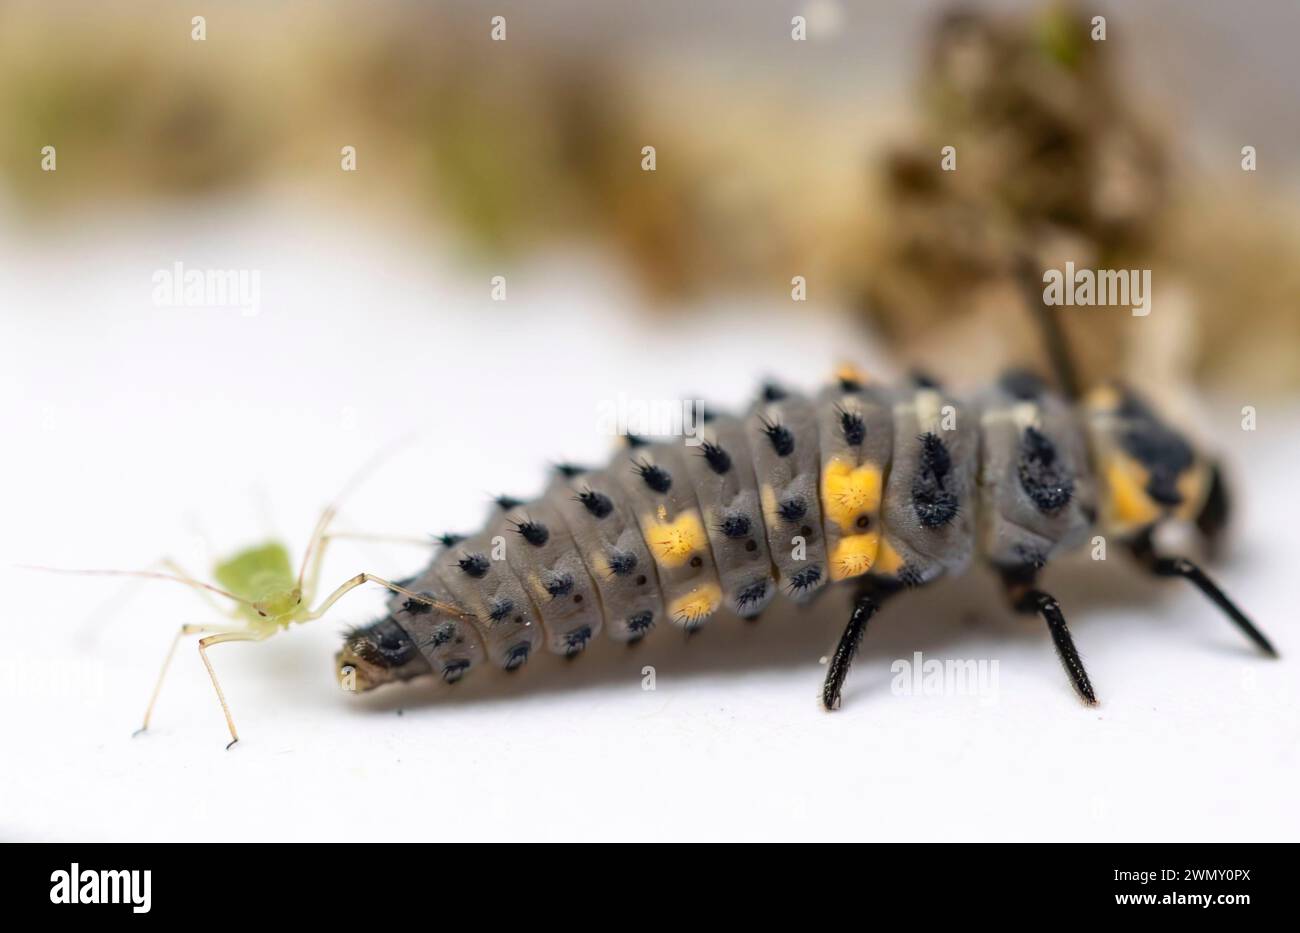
[1084, 386, 1229, 537]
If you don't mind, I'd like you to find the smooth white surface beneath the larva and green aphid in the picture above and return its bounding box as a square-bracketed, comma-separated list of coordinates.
[0, 205, 1300, 841]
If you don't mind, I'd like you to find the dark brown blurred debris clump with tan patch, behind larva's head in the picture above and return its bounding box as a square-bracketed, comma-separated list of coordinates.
[858, 5, 1300, 389]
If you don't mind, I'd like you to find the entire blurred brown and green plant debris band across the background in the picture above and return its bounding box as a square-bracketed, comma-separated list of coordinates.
[0, 0, 1300, 389]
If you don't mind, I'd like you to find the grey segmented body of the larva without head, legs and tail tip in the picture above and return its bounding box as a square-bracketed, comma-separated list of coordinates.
[390, 379, 1091, 681]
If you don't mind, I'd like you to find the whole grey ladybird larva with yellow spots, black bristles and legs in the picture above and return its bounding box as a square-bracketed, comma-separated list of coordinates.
[335, 368, 1275, 709]
